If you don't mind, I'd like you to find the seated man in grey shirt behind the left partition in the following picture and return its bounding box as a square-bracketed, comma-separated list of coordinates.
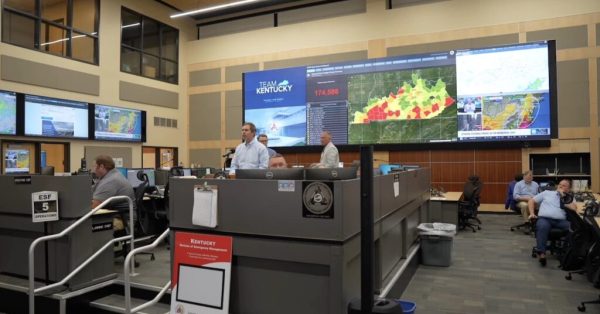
[92, 155, 135, 210]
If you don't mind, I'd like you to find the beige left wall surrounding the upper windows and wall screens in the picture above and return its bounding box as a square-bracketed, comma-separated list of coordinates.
[0, 0, 196, 170]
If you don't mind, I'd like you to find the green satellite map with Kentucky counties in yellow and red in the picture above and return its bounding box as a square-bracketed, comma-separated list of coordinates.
[348, 66, 457, 144]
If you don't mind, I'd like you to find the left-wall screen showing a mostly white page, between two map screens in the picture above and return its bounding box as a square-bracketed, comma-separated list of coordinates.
[25, 95, 89, 139]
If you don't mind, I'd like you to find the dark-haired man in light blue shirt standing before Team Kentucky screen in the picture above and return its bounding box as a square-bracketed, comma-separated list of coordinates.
[230, 122, 269, 175]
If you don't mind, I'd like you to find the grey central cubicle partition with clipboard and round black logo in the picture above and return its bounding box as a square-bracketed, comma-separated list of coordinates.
[169, 169, 430, 313]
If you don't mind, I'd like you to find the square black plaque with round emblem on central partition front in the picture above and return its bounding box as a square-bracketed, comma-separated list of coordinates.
[302, 182, 333, 219]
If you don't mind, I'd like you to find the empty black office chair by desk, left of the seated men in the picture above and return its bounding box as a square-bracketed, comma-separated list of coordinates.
[458, 175, 483, 232]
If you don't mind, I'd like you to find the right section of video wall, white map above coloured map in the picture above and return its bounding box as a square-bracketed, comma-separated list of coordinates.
[456, 44, 549, 136]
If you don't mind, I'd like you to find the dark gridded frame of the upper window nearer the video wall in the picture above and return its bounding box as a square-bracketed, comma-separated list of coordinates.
[119, 6, 180, 85]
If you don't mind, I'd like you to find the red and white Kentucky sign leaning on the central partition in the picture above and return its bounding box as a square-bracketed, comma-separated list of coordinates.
[171, 232, 233, 314]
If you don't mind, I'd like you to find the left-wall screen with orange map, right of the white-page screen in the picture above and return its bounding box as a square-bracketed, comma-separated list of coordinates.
[94, 104, 145, 142]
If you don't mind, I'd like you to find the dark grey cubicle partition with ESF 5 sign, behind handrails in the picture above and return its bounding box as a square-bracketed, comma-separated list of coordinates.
[0, 175, 116, 290]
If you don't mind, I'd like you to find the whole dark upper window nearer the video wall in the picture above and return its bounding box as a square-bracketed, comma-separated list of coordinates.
[121, 8, 179, 84]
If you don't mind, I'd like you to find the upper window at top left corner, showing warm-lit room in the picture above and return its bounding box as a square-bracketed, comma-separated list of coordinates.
[2, 0, 99, 64]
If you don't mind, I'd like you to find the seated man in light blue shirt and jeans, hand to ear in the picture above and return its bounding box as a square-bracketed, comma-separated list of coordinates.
[528, 179, 577, 266]
